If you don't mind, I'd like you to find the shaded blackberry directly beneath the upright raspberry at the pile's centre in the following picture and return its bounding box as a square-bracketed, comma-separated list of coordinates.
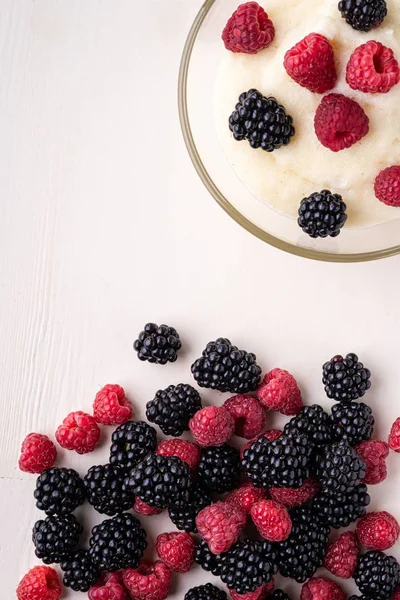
[197, 444, 241, 494]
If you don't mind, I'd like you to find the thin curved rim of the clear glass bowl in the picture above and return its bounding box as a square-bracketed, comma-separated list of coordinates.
[178, 0, 400, 263]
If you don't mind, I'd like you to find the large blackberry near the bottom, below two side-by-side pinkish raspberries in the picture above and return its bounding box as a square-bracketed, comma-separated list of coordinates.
[220, 539, 277, 594]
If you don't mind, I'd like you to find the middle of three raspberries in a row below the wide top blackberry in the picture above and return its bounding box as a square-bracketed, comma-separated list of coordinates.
[224, 394, 265, 440]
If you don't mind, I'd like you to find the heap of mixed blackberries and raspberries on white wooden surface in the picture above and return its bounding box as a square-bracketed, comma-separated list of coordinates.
[17, 326, 400, 600]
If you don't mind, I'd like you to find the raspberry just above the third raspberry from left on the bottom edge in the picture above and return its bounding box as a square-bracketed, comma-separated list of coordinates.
[156, 532, 196, 573]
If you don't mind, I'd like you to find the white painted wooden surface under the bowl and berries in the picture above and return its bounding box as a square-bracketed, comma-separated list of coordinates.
[0, 0, 400, 599]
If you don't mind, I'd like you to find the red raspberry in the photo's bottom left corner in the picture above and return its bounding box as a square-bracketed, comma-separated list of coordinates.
[17, 567, 62, 600]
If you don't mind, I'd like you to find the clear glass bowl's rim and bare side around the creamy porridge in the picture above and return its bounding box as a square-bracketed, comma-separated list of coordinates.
[178, 0, 400, 262]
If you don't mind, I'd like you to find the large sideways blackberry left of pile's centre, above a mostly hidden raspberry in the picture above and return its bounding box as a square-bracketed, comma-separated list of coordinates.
[124, 454, 191, 508]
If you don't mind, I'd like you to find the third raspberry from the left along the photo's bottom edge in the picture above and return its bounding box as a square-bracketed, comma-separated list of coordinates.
[122, 560, 171, 600]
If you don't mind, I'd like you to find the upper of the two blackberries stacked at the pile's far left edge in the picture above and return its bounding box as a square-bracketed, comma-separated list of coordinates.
[33, 467, 85, 515]
